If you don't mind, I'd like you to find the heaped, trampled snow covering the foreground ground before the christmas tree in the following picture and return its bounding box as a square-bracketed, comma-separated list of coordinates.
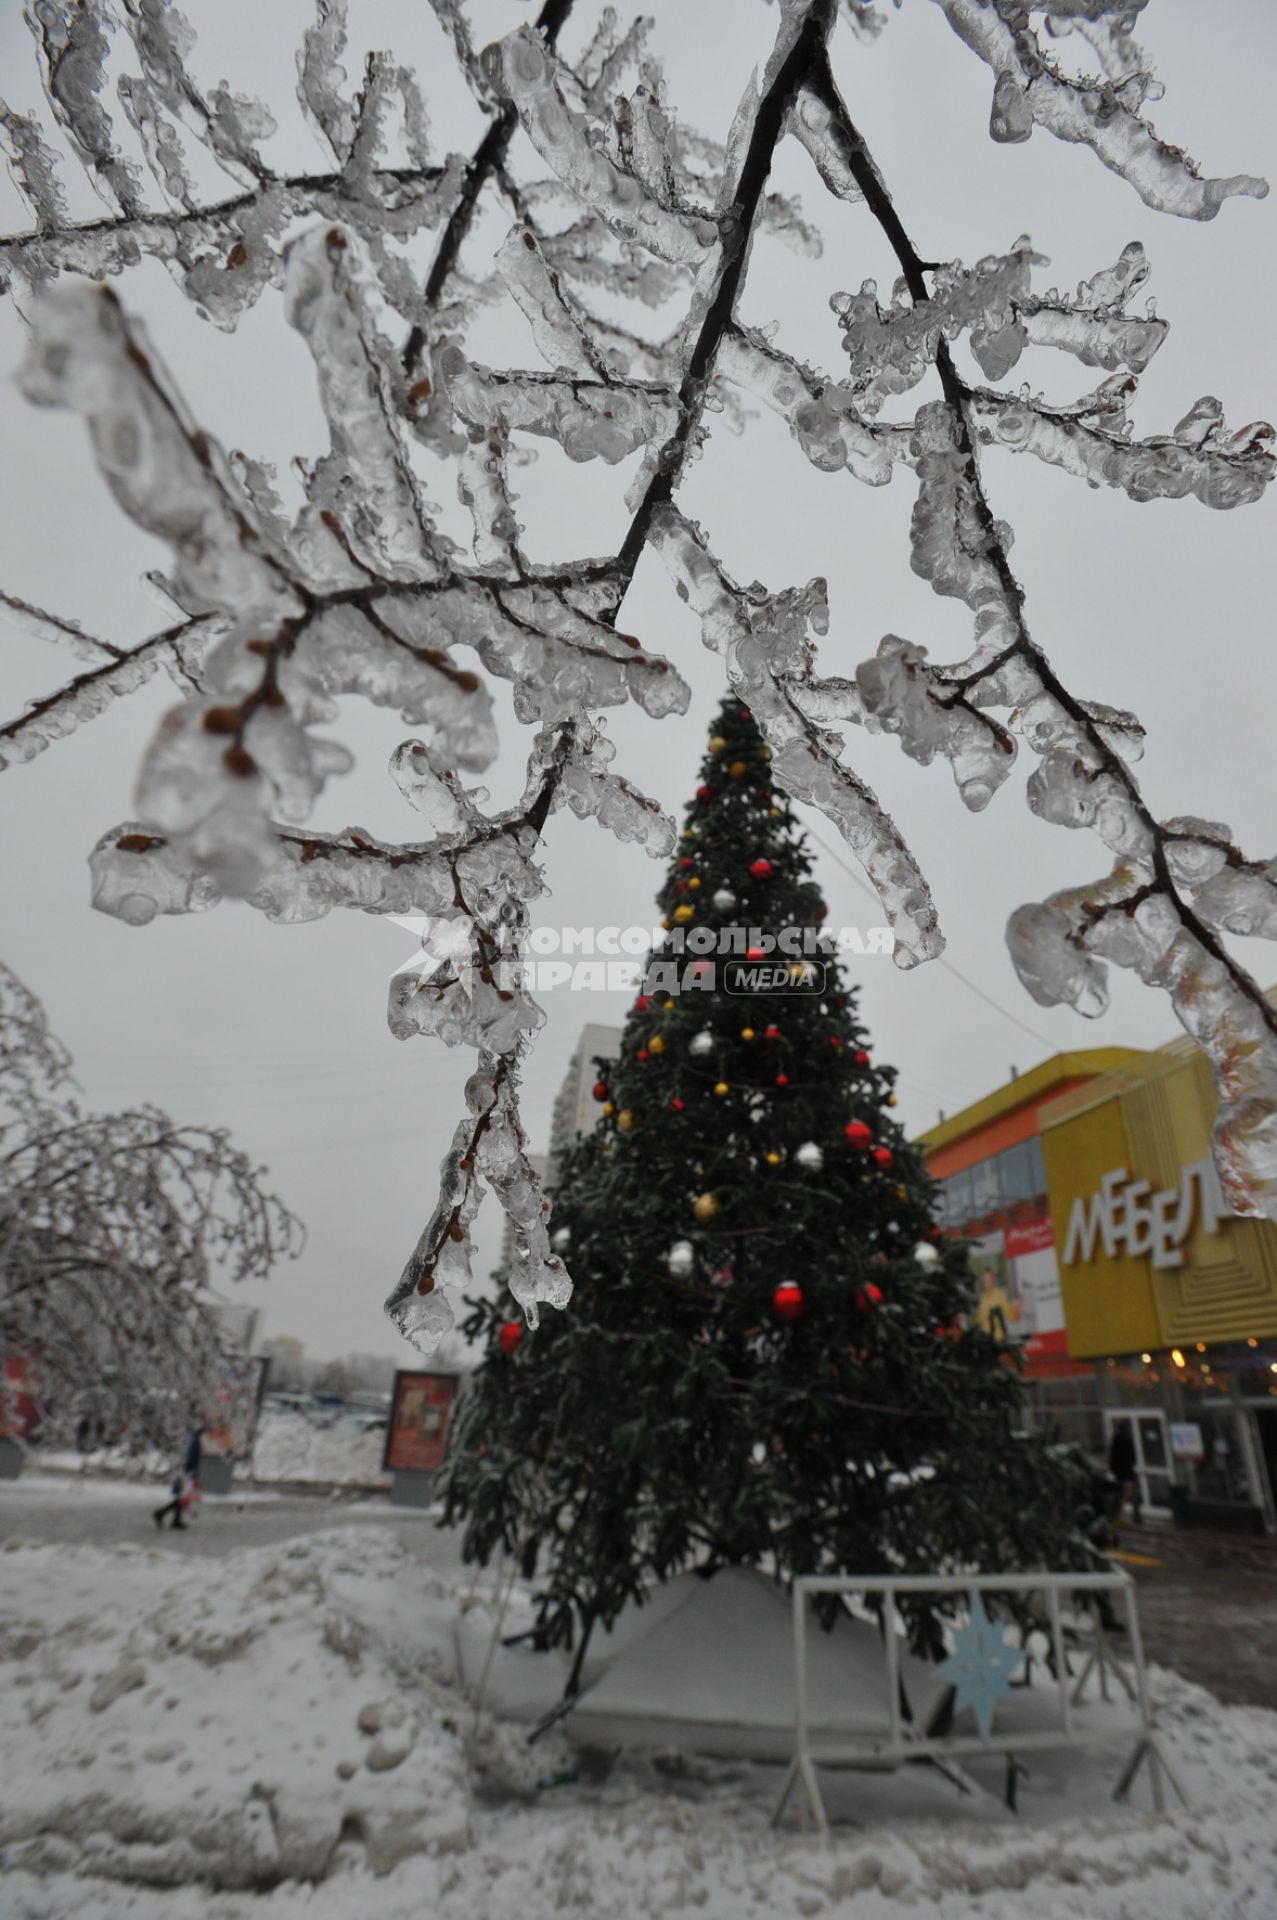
[0, 1526, 1277, 1920]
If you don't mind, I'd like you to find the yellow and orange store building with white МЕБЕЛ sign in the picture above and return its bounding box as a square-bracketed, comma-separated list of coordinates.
[918, 1039, 1277, 1530]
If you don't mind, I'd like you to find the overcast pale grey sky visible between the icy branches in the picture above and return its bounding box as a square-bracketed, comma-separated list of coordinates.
[0, 0, 1277, 1361]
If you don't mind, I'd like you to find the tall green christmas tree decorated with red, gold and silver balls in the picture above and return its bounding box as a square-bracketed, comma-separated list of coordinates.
[446, 701, 1077, 1666]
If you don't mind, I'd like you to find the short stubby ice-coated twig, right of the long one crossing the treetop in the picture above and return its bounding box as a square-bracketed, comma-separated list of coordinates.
[856, 634, 1016, 812]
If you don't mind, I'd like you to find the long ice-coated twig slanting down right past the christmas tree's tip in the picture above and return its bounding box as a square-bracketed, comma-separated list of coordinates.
[653, 509, 945, 968]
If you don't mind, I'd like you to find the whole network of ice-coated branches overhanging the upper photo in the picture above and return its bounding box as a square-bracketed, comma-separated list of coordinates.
[0, 0, 1277, 1350]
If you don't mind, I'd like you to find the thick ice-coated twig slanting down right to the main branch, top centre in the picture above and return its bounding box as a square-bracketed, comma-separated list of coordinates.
[484, 27, 718, 267]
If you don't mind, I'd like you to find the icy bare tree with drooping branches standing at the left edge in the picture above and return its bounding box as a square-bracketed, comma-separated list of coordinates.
[0, 966, 301, 1446]
